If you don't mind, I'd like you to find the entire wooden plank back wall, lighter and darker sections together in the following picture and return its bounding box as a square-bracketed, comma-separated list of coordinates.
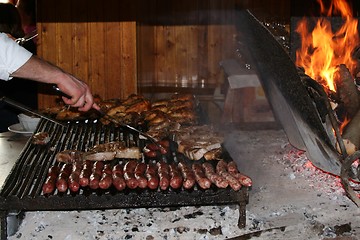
[37, 0, 289, 107]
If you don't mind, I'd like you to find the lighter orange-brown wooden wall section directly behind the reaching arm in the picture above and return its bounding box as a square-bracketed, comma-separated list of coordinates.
[37, 0, 137, 107]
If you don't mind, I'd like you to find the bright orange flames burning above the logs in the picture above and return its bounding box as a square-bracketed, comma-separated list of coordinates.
[296, 0, 359, 91]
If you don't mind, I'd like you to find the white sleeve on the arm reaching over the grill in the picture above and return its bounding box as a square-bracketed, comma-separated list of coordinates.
[0, 33, 32, 80]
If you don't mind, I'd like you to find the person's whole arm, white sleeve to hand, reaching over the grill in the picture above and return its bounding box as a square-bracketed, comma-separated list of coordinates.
[0, 33, 99, 111]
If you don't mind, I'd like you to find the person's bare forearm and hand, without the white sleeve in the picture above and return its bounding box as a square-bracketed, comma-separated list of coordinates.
[11, 56, 99, 111]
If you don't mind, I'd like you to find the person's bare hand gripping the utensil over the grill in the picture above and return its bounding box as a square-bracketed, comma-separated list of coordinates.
[57, 73, 100, 111]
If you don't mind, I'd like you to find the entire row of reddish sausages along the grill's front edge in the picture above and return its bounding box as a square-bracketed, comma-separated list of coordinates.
[43, 159, 252, 194]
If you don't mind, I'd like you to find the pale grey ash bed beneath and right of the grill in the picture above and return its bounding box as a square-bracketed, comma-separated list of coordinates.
[5, 130, 360, 240]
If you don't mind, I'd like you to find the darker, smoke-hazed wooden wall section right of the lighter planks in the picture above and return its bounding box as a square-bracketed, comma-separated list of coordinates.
[138, 0, 242, 87]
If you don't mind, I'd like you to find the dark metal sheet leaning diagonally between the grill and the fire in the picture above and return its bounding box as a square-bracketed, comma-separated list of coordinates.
[237, 10, 341, 175]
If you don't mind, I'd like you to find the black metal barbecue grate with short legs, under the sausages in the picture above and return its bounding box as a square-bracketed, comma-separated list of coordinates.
[0, 119, 248, 239]
